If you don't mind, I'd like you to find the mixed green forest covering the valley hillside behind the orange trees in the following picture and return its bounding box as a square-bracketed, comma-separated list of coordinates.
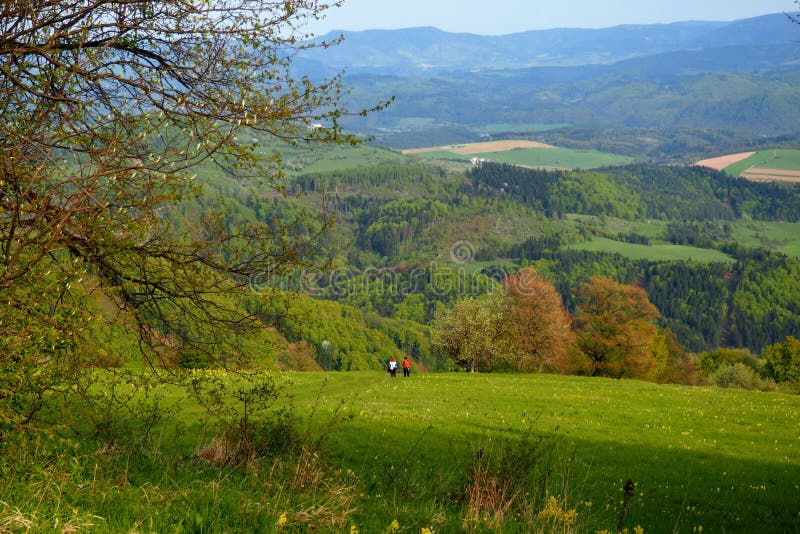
[239, 157, 800, 392]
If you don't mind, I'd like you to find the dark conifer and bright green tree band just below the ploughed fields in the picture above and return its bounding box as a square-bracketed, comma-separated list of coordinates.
[466, 163, 800, 222]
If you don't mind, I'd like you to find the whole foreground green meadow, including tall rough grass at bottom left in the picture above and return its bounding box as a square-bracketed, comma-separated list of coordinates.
[0, 371, 800, 533]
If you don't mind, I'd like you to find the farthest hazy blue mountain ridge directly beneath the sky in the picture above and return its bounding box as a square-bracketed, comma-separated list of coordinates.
[302, 13, 800, 75]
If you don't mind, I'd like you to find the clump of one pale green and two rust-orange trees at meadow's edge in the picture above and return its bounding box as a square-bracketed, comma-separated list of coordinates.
[433, 267, 690, 380]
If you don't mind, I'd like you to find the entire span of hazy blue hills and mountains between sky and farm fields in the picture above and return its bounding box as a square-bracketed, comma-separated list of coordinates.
[302, 14, 800, 140]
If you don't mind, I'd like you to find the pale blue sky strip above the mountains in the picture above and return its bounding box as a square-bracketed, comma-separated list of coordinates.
[309, 0, 797, 35]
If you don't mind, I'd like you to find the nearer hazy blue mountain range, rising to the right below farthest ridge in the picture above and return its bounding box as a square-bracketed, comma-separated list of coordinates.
[347, 43, 800, 135]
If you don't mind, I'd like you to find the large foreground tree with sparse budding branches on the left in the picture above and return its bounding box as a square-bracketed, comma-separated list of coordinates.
[0, 0, 382, 436]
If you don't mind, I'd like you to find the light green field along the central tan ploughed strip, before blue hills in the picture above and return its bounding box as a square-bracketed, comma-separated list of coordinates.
[419, 148, 633, 169]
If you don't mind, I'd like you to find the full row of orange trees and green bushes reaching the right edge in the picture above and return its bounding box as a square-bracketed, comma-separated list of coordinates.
[432, 267, 800, 391]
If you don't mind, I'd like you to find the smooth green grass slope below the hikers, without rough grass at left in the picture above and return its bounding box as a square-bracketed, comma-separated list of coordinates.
[284, 373, 800, 533]
